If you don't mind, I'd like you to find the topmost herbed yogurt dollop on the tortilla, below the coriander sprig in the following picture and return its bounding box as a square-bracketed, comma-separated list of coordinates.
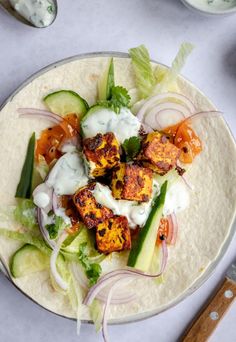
[81, 108, 141, 143]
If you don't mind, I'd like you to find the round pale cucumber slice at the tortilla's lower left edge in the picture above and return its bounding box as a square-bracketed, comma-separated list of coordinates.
[10, 244, 49, 278]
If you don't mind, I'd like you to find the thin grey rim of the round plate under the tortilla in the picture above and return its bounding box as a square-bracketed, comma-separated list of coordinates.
[0, 51, 236, 325]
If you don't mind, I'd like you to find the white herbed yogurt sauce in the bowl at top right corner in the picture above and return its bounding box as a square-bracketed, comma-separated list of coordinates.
[188, 0, 236, 11]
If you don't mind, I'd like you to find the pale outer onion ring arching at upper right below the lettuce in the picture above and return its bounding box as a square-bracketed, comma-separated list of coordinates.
[137, 92, 195, 121]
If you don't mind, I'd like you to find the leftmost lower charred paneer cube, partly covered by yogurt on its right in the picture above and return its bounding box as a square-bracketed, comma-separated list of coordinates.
[73, 183, 113, 229]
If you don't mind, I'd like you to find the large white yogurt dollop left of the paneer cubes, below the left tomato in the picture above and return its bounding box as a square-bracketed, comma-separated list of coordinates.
[46, 152, 88, 196]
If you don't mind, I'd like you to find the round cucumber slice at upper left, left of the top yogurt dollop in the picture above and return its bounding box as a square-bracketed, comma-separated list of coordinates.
[43, 90, 89, 117]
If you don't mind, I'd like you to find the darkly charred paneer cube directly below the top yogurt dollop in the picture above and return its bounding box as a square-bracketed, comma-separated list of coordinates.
[83, 132, 120, 177]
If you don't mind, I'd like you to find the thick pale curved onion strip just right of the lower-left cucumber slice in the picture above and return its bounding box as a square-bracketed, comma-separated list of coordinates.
[50, 232, 68, 291]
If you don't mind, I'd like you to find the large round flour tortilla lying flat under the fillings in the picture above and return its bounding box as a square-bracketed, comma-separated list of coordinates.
[0, 55, 236, 323]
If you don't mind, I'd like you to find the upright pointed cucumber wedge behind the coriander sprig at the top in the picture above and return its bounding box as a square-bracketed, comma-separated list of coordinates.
[98, 58, 115, 101]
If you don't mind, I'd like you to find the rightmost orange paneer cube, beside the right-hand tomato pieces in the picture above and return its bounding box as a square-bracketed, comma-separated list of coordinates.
[137, 132, 180, 175]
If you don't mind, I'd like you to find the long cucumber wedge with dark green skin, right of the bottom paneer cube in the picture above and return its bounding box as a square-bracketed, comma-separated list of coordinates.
[128, 181, 167, 271]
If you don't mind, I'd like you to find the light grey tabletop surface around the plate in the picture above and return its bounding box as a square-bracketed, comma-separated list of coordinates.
[0, 0, 236, 342]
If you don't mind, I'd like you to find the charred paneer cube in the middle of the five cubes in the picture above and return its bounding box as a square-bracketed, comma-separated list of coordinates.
[111, 163, 153, 202]
